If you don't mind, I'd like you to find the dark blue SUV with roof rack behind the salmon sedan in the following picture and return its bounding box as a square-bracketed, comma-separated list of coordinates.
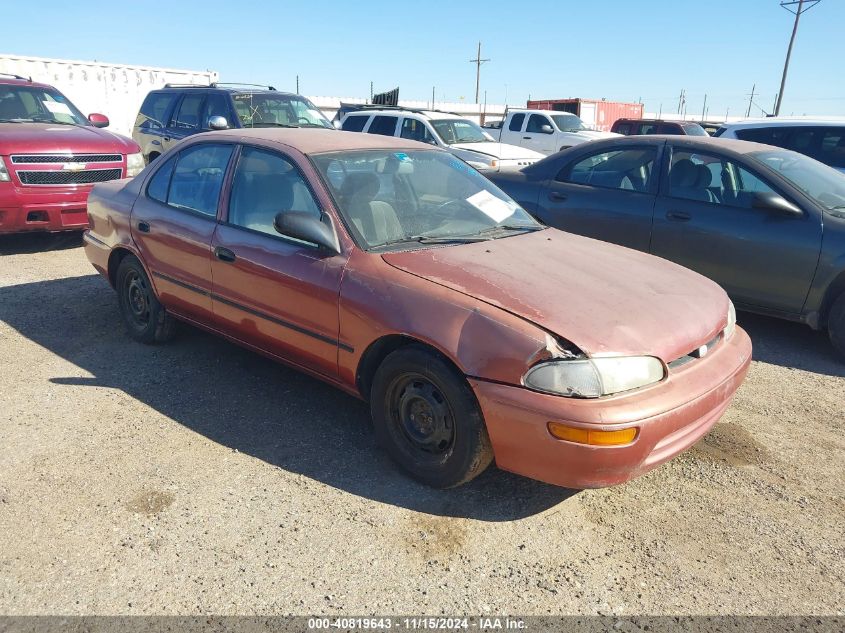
[132, 83, 334, 163]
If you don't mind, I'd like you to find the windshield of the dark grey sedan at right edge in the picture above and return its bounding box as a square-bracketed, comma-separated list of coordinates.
[751, 150, 845, 210]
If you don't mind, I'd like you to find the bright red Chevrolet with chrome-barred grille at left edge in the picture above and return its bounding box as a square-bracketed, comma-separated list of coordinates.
[0, 75, 144, 234]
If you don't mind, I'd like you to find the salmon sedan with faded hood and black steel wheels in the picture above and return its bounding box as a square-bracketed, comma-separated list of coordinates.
[85, 129, 751, 488]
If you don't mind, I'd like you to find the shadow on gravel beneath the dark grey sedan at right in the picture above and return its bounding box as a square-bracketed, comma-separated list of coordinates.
[738, 312, 845, 377]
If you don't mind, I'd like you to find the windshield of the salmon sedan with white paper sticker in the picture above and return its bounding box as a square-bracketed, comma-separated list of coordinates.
[313, 149, 544, 249]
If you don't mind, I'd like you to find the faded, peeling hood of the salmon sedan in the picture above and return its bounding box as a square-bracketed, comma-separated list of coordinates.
[382, 229, 728, 363]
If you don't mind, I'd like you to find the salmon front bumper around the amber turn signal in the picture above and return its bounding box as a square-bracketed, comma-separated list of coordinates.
[470, 327, 751, 488]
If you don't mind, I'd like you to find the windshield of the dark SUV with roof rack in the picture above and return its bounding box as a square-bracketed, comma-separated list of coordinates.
[232, 92, 334, 129]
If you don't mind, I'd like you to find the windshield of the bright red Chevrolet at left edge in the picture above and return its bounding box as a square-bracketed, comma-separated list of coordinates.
[0, 84, 90, 125]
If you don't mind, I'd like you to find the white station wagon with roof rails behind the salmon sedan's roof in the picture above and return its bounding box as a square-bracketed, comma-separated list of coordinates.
[340, 107, 545, 172]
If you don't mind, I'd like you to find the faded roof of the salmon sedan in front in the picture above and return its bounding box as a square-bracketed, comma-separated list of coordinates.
[201, 128, 432, 154]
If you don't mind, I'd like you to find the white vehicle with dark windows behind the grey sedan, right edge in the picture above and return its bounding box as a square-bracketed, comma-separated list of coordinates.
[715, 117, 845, 172]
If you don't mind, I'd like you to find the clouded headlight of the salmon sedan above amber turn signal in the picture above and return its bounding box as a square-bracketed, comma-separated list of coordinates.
[523, 356, 665, 398]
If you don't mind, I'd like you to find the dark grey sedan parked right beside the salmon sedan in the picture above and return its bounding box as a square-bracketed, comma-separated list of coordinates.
[491, 136, 845, 355]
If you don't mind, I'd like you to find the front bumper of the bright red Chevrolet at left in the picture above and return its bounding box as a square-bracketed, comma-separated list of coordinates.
[0, 182, 93, 234]
